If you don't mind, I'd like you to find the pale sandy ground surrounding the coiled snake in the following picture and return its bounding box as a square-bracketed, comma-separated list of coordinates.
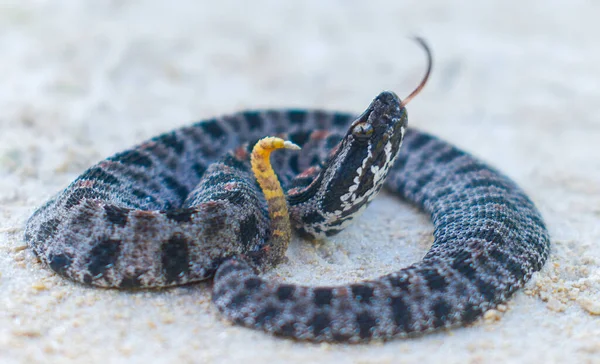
[0, 0, 600, 363]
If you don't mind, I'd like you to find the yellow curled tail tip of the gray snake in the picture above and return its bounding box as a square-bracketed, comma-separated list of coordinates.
[251, 137, 300, 266]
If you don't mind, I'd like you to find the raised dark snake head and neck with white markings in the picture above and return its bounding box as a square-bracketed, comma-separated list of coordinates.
[292, 91, 407, 238]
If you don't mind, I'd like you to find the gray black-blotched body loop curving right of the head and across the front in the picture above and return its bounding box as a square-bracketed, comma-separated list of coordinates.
[213, 130, 550, 343]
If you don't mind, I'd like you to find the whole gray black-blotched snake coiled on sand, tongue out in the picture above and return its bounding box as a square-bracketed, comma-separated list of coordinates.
[25, 42, 550, 343]
